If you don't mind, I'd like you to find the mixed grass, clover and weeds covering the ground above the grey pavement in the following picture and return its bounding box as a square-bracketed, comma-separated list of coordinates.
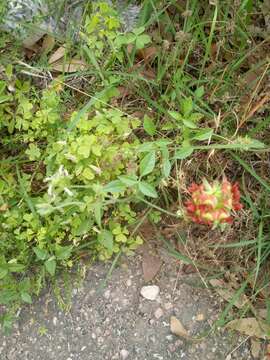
[0, 0, 270, 338]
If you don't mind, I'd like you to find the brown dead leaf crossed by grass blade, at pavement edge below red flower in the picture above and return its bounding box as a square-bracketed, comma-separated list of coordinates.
[209, 279, 249, 309]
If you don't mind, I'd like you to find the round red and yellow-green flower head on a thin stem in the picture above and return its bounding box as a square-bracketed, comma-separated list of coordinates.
[185, 179, 242, 227]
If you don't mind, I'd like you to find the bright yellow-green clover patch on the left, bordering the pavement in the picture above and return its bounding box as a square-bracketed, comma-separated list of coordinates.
[0, 74, 147, 327]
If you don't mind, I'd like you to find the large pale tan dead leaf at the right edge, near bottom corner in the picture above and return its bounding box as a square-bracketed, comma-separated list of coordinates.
[226, 318, 270, 339]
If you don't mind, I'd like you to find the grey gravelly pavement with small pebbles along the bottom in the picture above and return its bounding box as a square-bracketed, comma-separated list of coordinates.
[0, 255, 252, 360]
